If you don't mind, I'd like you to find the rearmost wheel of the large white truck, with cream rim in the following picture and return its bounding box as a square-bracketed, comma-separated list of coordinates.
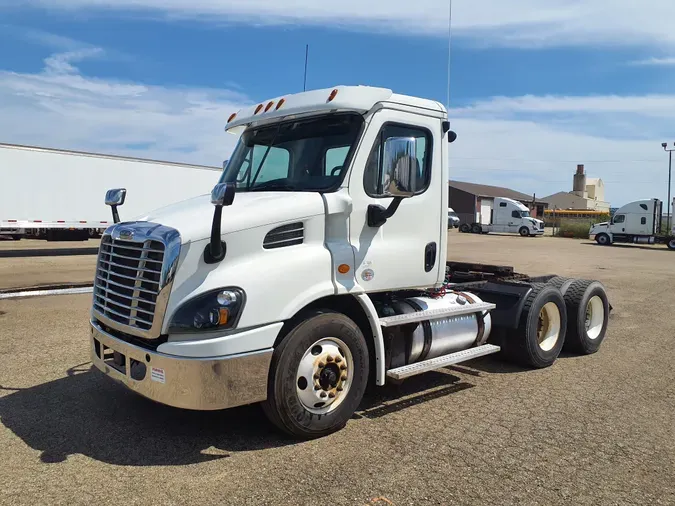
[565, 279, 609, 355]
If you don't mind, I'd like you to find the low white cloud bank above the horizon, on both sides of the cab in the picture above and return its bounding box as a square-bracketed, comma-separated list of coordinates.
[0, 49, 675, 204]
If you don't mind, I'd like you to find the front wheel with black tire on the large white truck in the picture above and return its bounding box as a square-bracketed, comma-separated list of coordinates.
[262, 310, 370, 439]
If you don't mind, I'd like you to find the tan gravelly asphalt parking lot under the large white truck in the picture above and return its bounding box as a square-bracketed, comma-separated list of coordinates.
[0, 231, 675, 506]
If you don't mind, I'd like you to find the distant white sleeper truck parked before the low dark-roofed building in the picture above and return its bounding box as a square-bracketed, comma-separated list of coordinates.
[459, 197, 544, 237]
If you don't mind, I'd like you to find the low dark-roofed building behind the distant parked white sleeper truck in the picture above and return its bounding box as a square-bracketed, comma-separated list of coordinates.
[448, 180, 548, 223]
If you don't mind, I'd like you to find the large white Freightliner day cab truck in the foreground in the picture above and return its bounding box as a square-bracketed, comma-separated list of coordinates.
[90, 86, 611, 439]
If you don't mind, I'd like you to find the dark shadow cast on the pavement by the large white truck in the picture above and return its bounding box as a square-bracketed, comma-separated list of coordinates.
[0, 363, 473, 466]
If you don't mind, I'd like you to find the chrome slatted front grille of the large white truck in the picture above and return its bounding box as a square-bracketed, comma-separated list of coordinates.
[94, 235, 165, 332]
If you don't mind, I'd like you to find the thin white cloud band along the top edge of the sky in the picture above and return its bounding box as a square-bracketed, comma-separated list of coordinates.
[0, 0, 675, 47]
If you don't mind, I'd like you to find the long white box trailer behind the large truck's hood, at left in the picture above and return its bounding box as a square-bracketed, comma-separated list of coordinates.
[0, 144, 222, 239]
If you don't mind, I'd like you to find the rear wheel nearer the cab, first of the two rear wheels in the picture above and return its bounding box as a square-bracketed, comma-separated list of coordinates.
[504, 283, 567, 369]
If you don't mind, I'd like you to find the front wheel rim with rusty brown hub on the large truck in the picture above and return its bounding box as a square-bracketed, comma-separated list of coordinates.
[295, 337, 354, 415]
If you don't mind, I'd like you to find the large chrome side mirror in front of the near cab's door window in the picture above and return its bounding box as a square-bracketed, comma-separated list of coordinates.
[380, 137, 419, 198]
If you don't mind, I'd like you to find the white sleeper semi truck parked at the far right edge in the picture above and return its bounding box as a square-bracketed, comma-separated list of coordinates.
[589, 199, 675, 250]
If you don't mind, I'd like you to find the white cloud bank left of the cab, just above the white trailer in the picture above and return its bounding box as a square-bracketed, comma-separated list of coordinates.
[0, 48, 249, 166]
